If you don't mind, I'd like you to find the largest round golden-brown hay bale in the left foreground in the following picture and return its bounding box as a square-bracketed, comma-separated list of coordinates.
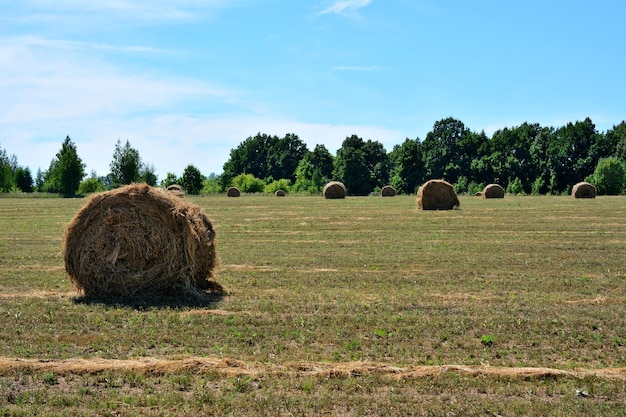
[63, 184, 221, 298]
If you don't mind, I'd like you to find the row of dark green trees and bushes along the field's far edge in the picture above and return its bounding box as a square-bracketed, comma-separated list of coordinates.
[0, 117, 626, 196]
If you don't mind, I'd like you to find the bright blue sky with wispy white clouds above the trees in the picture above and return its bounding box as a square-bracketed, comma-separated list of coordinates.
[0, 0, 626, 179]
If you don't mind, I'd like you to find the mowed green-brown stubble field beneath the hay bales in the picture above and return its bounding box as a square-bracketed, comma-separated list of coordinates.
[0, 195, 626, 416]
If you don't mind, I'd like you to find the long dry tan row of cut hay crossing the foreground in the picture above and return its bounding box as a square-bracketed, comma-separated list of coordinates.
[0, 357, 626, 381]
